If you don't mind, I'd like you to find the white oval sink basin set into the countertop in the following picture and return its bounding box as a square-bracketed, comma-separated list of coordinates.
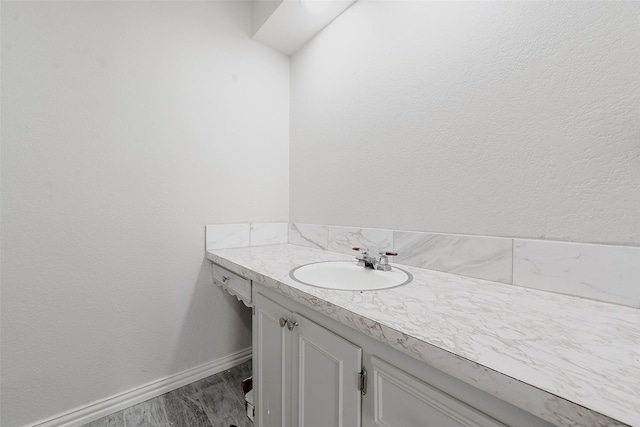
[289, 261, 413, 291]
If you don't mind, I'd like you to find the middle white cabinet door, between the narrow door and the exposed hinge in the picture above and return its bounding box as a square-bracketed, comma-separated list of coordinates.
[292, 314, 362, 427]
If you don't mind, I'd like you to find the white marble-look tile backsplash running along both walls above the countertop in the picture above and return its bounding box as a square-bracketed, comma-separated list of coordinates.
[207, 222, 640, 308]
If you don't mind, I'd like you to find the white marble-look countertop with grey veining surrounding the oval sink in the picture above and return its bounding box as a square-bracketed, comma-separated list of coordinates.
[207, 245, 640, 427]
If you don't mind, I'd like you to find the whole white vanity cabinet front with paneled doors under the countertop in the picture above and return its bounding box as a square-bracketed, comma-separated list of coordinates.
[253, 282, 550, 427]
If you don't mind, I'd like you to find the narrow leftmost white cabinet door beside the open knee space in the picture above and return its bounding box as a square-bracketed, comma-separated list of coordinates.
[253, 294, 292, 427]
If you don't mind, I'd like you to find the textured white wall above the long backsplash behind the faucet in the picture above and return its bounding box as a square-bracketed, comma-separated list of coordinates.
[290, 0, 640, 245]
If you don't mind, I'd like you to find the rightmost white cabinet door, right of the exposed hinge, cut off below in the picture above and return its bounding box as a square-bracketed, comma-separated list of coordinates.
[364, 357, 505, 427]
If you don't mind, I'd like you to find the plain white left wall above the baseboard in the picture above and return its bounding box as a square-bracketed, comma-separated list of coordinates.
[0, 1, 289, 427]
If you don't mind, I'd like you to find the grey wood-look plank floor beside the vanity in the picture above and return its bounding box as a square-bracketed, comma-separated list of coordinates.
[83, 361, 253, 427]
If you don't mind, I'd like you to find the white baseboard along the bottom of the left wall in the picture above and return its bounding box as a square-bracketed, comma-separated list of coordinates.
[24, 347, 251, 427]
